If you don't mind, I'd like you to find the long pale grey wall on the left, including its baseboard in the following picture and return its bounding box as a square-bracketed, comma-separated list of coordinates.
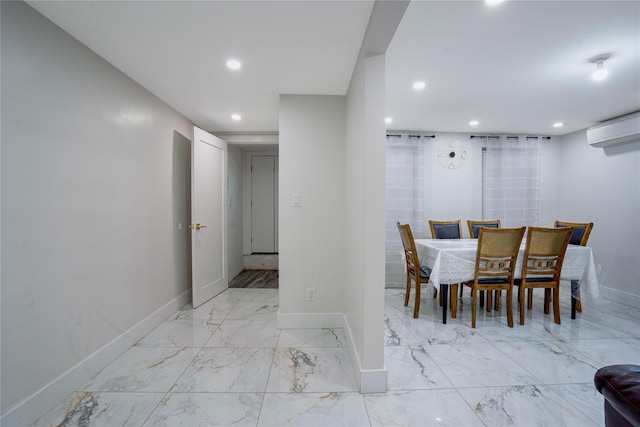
[1, 2, 192, 425]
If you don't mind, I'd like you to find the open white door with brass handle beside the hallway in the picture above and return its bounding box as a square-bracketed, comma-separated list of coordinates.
[189, 126, 228, 308]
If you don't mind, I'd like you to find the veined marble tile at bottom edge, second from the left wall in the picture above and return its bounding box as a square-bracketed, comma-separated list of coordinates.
[144, 393, 263, 427]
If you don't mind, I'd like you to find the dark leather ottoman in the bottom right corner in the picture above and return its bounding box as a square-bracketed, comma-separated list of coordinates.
[593, 365, 640, 427]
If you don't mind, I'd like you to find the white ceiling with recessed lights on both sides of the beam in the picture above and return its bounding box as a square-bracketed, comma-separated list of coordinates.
[28, 0, 640, 135]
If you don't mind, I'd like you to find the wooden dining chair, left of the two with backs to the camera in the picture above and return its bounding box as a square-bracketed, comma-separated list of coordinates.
[465, 227, 526, 328]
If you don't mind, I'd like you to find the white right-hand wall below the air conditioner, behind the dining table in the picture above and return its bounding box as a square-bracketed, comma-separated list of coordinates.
[557, 130, 640, 307]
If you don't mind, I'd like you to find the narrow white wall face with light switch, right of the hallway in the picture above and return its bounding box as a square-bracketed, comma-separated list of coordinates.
[279, 95, 345, 318]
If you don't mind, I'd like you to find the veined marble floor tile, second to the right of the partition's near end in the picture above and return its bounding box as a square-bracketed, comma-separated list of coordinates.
[425, 343, 540, 387]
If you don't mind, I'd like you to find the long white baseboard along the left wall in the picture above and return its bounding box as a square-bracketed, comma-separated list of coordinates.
[0, 290, 191, 426]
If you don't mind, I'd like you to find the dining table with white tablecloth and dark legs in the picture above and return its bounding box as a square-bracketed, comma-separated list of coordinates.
[415, 239, 600, 324]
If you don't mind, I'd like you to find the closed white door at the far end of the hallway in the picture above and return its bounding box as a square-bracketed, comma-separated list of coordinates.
[251, 156, 278, 253]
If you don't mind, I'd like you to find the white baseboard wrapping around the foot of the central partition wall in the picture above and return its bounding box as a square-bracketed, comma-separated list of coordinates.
[278, 312, 387, 393]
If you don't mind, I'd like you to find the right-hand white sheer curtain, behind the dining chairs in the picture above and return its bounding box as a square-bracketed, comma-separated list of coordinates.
[482, 136, 541, 227]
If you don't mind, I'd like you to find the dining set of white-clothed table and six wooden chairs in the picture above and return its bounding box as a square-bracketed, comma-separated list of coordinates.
[396, 220, 602, 328]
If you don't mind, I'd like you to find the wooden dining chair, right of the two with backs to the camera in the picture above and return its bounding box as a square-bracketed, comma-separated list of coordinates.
[514, 227, 573, 325]
